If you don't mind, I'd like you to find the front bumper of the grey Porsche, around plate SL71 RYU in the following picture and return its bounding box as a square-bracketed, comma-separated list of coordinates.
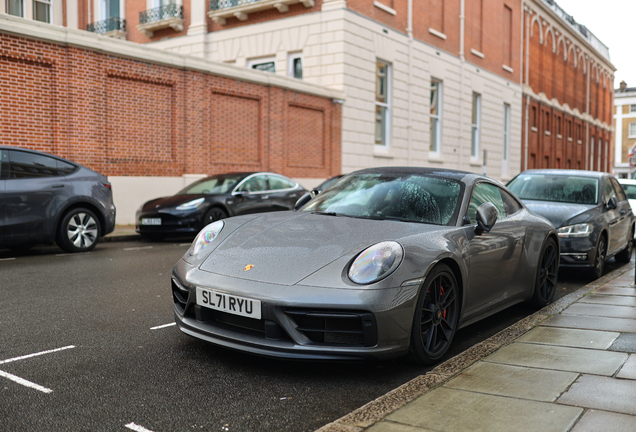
[172, 260, 419, 360]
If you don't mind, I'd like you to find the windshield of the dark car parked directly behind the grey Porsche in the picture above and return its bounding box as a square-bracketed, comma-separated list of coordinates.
[508, 174, 598, 204]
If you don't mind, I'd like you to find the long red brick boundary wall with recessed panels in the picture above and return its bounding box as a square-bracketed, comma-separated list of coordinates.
[0, 34, 341, 178]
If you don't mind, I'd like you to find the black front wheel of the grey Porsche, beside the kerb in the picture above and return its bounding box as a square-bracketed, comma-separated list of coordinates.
[409, 264, 459, 365]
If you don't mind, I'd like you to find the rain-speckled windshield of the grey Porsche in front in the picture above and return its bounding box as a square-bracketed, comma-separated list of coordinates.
[302, 174, 462, 225]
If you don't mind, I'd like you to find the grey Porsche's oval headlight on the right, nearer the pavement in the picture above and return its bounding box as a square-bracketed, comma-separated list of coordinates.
[349, 241, 404, 285]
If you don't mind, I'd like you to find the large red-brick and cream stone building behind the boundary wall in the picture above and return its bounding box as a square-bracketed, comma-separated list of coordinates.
[0, 0, 614, 181]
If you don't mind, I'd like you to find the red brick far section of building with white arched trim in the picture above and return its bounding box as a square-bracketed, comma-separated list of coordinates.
[522, 8, 614, 171]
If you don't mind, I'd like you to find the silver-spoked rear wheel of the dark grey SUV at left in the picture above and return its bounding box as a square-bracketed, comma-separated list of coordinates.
[57, 208, 101, 252]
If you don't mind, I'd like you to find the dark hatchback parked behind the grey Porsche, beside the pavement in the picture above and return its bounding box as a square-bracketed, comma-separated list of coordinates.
[508, 169, 634, 279]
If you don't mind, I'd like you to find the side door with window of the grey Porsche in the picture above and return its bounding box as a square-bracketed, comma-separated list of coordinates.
[466, 182, 525, 313]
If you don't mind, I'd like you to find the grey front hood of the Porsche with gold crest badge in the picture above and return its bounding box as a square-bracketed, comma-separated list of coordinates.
[199, 212, 447, 285]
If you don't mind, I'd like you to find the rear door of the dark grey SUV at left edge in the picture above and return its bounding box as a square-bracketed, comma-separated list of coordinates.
[3, 150, 72, 243]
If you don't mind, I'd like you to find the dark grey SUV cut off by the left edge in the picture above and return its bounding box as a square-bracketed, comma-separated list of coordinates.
[0, 146, 115, 252]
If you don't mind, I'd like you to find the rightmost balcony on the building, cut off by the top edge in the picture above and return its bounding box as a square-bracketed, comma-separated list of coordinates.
[208, 0, 315, 25]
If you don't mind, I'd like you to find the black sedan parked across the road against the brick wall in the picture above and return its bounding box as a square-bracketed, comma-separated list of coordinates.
[135, 172, 306, 240]
